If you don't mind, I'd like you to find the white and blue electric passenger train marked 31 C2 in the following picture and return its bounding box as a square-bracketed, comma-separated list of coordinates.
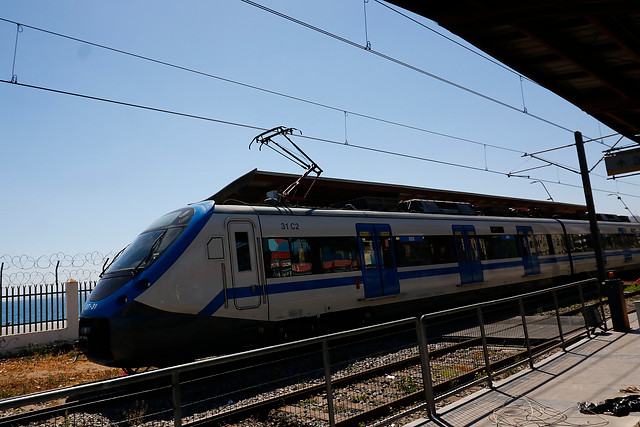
[79, 200, 640, 369]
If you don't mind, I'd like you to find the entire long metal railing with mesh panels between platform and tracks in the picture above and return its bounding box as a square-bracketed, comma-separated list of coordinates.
[0, 279, 604, 426]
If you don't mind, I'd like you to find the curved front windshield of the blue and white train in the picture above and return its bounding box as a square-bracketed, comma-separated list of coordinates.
[105, 208, 194, 275]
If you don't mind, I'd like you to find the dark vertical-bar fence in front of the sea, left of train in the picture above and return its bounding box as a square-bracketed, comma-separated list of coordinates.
[0, 282, 96, 335]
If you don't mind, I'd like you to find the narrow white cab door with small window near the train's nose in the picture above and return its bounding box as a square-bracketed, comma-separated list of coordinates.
[227, 221, 263, 309]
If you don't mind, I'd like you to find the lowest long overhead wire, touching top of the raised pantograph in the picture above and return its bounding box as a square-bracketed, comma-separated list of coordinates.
[0, 79, 640, 202]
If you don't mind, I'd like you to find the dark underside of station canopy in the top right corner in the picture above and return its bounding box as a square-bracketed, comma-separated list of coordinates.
[388, 0, 640, 143]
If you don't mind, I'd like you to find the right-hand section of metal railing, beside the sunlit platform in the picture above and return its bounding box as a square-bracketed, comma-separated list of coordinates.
[420, 279, 606, 422]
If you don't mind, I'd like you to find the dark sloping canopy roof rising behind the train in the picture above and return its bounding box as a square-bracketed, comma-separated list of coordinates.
[207, 169, 629, 222]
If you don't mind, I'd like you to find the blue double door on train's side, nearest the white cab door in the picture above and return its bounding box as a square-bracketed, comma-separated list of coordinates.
[356, 224, 400, 298]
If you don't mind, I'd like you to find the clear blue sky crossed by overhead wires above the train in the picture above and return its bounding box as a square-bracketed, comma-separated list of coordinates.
[0, 0, 640, 262]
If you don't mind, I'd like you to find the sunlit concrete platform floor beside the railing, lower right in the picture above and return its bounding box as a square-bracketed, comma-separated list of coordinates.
[405, 314, 640, 427]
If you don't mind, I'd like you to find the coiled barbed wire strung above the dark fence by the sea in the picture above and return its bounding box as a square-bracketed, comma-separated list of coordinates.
[0, 251, 114, 286]
